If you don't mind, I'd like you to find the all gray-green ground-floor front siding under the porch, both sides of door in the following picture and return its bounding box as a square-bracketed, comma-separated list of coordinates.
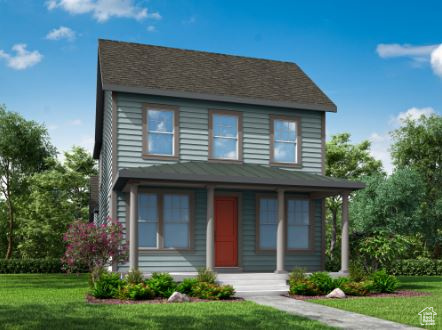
[118, 189, 322, 272]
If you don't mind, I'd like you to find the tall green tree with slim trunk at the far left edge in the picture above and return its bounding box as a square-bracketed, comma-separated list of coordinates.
[0, 106, 55, 259]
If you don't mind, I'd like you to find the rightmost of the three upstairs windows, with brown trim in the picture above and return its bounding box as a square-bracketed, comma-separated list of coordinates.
[270, 116, 301, 166]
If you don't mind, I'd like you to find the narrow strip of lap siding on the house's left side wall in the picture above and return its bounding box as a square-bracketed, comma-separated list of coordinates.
[98, 91, 112, 223]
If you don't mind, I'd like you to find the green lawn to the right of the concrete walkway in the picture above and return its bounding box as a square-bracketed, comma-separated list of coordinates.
[309, 276, 442, 329]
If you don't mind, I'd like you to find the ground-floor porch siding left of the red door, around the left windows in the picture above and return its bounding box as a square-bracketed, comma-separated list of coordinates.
[117, 189, 207, 272]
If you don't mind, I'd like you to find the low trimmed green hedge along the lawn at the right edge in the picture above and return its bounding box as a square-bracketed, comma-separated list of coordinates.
[387, 258, 442, 276]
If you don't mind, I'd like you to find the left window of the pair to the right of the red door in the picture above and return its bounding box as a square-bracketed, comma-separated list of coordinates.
[258, 197, 278, 250]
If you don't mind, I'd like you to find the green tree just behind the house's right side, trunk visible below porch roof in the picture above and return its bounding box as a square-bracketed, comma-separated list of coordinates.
[325, 133, 382, 258]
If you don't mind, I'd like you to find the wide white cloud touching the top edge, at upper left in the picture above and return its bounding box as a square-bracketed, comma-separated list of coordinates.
[46, 0, 162, 22]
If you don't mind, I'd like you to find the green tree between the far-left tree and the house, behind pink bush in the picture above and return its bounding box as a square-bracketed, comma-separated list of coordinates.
[17, 147, 97, 258]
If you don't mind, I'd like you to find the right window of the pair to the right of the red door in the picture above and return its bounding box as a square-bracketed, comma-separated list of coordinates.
[287, 199, 310, 250]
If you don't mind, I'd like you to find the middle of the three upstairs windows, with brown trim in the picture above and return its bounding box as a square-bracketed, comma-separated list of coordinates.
[209, 111, 242, 161]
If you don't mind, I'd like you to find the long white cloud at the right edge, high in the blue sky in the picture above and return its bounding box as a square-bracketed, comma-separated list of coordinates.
[376, 44, 442, 77]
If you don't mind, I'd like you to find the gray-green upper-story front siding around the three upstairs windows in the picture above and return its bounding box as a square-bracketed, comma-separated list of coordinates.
[117, 94, 322, 173]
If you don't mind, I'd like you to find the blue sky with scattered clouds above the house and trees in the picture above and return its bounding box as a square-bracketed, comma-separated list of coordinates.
[0, 0, 442, 172]
